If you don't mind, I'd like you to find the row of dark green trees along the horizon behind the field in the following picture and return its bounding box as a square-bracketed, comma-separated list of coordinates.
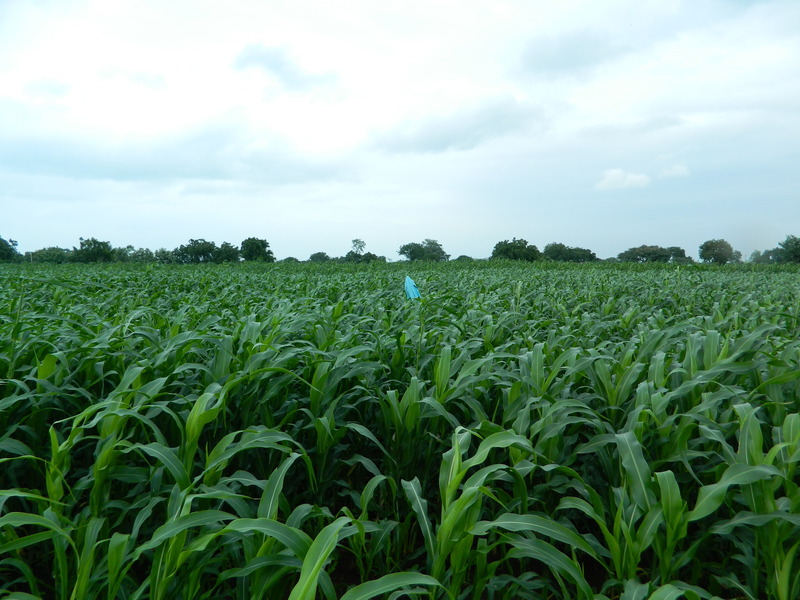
[0, 235, 800, 264]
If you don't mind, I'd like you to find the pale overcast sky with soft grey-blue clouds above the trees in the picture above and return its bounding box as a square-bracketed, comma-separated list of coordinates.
[0, 0, 800, 260]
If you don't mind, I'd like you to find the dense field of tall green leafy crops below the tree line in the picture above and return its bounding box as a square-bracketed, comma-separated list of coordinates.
[0, 263, 800, 600]
